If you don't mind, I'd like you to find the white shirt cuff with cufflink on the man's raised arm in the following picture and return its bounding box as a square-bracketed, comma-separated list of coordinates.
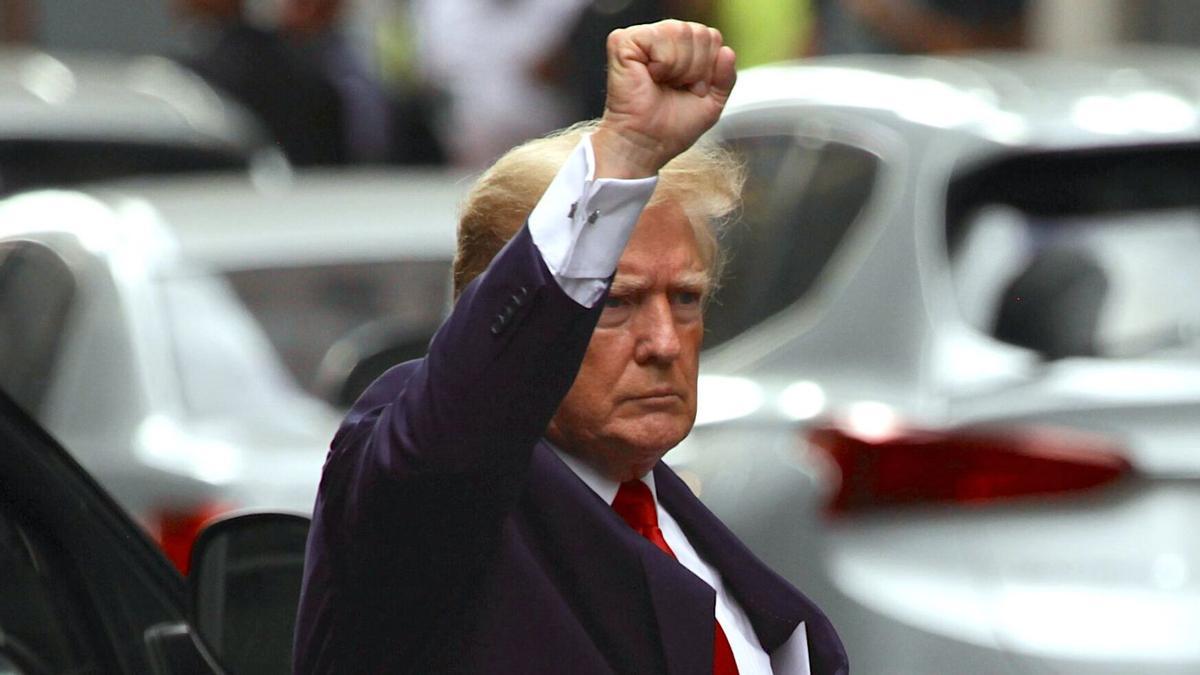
[529, 136, 659, 307]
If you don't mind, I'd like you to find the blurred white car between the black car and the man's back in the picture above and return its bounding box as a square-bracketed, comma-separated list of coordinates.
[0, 172, 461, 563]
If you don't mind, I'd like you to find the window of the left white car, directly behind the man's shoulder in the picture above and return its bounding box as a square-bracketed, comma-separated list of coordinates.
[227, 259, 450, 393]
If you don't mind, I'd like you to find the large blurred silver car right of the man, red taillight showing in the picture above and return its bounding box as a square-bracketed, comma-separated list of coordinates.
[667, 52, 1200, 674]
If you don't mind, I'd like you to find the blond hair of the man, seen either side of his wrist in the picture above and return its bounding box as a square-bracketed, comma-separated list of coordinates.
[454, 120, 745, 298]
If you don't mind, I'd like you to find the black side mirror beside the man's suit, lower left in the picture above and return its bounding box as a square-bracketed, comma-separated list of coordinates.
[188, 513, 310, 675]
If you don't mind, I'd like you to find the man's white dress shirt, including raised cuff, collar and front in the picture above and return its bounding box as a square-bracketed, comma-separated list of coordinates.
[529, 138, 772, 675]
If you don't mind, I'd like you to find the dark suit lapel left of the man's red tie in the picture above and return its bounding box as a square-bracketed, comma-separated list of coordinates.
[517, 443, 715, 675]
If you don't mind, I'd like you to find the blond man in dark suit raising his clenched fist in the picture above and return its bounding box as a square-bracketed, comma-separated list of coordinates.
[295, 22, 847, 675]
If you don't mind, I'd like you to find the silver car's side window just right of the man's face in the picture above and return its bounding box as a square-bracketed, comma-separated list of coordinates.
[704, 135, 880, 347]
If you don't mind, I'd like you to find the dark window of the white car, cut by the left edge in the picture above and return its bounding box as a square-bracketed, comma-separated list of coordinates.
[0, 241, 76, 414]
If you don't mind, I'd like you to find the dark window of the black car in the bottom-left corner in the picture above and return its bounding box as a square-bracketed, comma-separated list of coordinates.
[0, 502, 104, 673]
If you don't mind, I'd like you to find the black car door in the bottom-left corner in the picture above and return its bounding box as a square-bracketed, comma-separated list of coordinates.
[0, 392, 222, 675]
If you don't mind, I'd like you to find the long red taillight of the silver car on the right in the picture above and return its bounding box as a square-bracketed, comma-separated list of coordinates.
[808, 426, 1133, 513]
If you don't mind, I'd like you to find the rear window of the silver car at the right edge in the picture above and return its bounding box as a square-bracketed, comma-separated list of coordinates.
[948, 148, 1200, 358]
